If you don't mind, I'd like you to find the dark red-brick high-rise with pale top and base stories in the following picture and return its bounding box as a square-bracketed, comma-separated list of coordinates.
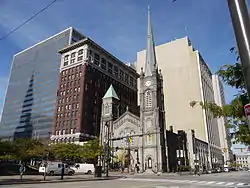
[51, 38, 139, 143]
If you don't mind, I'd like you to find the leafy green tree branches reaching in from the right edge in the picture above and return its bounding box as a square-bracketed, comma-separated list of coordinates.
[190, 48, 250, 145]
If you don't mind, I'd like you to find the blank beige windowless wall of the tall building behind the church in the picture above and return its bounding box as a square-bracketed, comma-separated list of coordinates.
[136, 37, 208, 141]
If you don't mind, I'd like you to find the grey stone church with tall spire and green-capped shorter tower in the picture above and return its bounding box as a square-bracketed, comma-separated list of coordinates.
[100, 8, 167, 172]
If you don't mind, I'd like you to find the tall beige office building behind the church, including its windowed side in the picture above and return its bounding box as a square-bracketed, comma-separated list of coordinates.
[136, 37, 223, 167]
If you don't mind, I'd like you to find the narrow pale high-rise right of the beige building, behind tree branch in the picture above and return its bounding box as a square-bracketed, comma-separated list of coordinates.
[212, 75, 233, 164]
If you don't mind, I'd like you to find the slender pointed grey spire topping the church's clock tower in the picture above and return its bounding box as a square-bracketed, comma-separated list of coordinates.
[145, 6, 157, 77]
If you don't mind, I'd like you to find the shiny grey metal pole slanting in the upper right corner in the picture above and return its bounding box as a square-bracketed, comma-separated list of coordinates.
[227, 0, 250, 97]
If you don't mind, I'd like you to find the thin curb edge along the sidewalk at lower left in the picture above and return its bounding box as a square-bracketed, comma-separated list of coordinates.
[0, 176, 124, 185]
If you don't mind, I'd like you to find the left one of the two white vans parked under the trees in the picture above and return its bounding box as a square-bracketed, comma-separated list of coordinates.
[39, 162, 75, 176]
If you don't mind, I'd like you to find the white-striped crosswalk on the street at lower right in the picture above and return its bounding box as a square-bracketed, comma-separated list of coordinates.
[119, 178, 249, 187]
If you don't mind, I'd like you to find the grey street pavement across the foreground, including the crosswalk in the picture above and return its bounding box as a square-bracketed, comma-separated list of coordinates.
[2, 172, 250, 188]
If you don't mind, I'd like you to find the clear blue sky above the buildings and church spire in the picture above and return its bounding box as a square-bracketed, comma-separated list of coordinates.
[0, 0, 247, 151]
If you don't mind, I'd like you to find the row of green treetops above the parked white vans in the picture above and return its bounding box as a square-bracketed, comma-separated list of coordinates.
[0, 139, 103, 162]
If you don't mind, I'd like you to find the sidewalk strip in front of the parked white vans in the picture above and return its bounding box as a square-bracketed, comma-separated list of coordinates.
[0, 175, 122, 185]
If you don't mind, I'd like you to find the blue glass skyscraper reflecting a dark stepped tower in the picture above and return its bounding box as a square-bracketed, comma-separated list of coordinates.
[0, 28, 84, 139]
